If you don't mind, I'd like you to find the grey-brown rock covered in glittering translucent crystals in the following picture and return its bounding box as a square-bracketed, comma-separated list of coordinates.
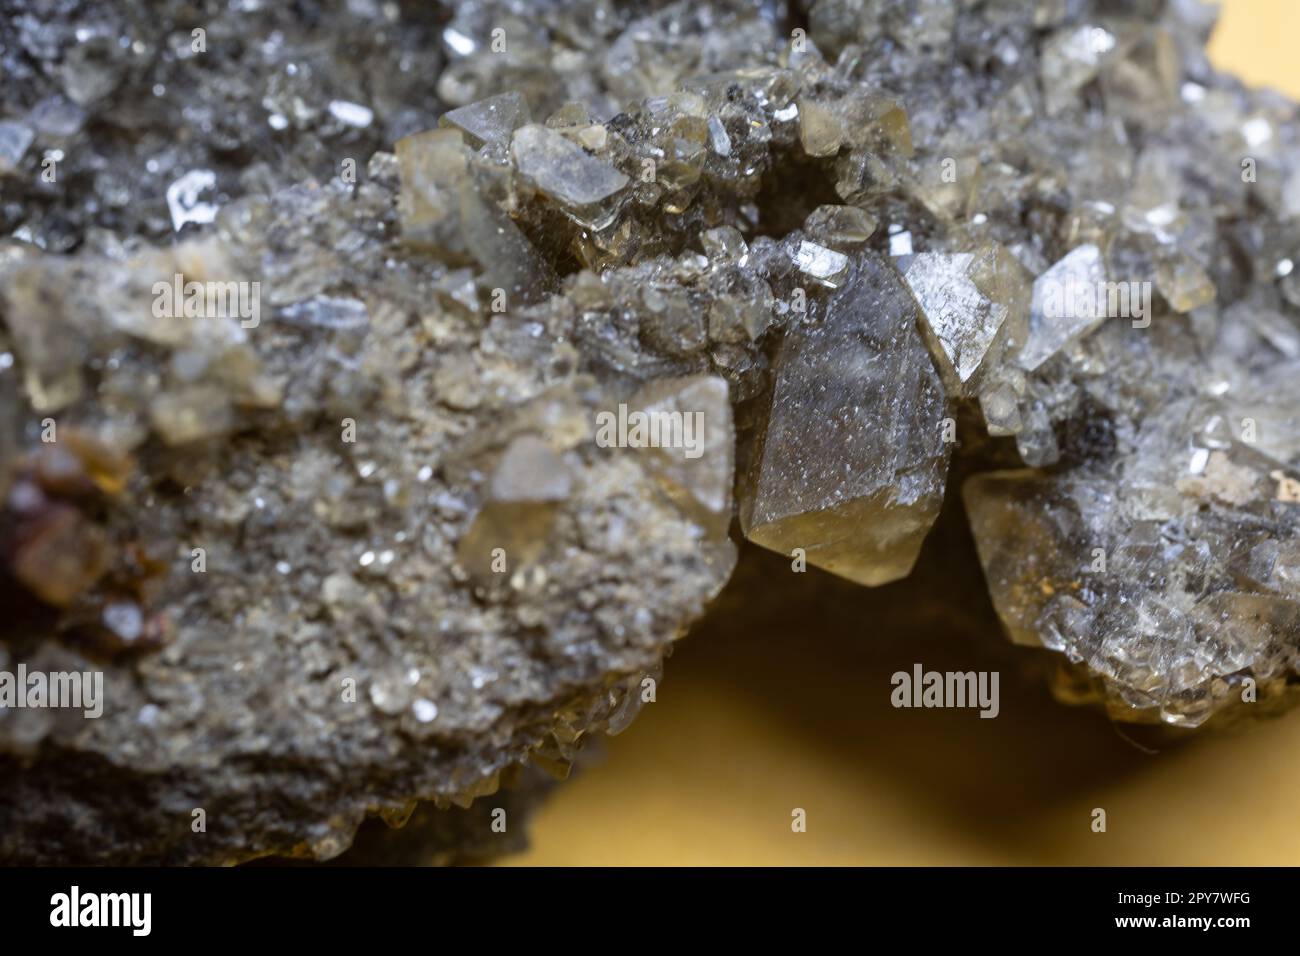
[0, 0, 1300, 862]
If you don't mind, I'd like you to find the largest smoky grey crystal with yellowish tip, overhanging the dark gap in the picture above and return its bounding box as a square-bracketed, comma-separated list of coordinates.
[741, 256, 949, 585]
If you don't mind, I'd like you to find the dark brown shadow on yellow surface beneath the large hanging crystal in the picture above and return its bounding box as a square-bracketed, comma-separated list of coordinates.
[666, 494, 1188, 845]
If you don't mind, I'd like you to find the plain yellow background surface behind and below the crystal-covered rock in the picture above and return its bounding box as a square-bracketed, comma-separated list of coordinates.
[506, 0, 1300, 865]
